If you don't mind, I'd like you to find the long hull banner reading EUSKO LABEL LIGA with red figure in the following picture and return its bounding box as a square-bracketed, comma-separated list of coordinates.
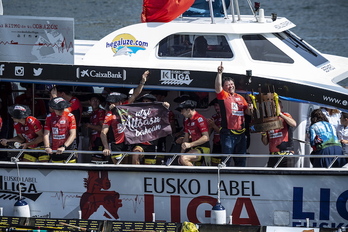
[0, 167, 348, 228]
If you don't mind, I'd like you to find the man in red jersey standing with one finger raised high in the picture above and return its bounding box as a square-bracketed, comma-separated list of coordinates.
[215, 62, 253, 167]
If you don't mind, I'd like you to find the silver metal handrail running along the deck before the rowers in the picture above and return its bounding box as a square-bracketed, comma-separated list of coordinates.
[0, 148, 348, 169]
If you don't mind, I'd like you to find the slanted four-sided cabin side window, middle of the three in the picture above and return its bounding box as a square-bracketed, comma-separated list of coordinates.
[242, 35, 294, 64]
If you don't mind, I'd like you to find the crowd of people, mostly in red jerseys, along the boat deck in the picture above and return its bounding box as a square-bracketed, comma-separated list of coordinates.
[0, 64, 348, 167]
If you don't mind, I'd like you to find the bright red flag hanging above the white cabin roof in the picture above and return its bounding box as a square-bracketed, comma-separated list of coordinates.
[141, 0, 195, 23]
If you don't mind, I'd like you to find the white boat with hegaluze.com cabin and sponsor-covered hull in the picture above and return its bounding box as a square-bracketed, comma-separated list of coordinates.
[0, 1, 348, 228]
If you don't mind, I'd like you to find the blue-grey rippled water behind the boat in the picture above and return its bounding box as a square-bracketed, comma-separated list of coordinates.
[3, 0, 348, 57]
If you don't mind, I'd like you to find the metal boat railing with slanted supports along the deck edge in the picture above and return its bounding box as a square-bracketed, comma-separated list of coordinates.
[0, 148, 348, 169]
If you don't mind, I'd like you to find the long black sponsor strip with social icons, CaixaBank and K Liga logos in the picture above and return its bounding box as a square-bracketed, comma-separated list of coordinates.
[0, 61, 348, 111]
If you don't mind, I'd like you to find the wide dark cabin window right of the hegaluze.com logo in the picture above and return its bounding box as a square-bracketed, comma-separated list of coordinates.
[158, 34, 233, 58]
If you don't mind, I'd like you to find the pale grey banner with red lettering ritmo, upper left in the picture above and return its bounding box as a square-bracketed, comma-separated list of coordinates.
[0, 15, 74, 64]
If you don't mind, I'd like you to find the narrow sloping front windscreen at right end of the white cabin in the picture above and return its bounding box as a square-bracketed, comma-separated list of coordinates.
[274, 31, 328, 66]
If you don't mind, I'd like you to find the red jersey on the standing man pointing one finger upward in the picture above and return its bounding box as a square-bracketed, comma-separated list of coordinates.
[216, 90, 248, 130]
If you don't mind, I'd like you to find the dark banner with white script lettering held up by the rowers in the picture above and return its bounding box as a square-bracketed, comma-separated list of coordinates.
[116, 102, 172, 144]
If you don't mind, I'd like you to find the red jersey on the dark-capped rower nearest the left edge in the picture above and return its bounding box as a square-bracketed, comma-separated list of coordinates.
[13, 116, 42, 148]
